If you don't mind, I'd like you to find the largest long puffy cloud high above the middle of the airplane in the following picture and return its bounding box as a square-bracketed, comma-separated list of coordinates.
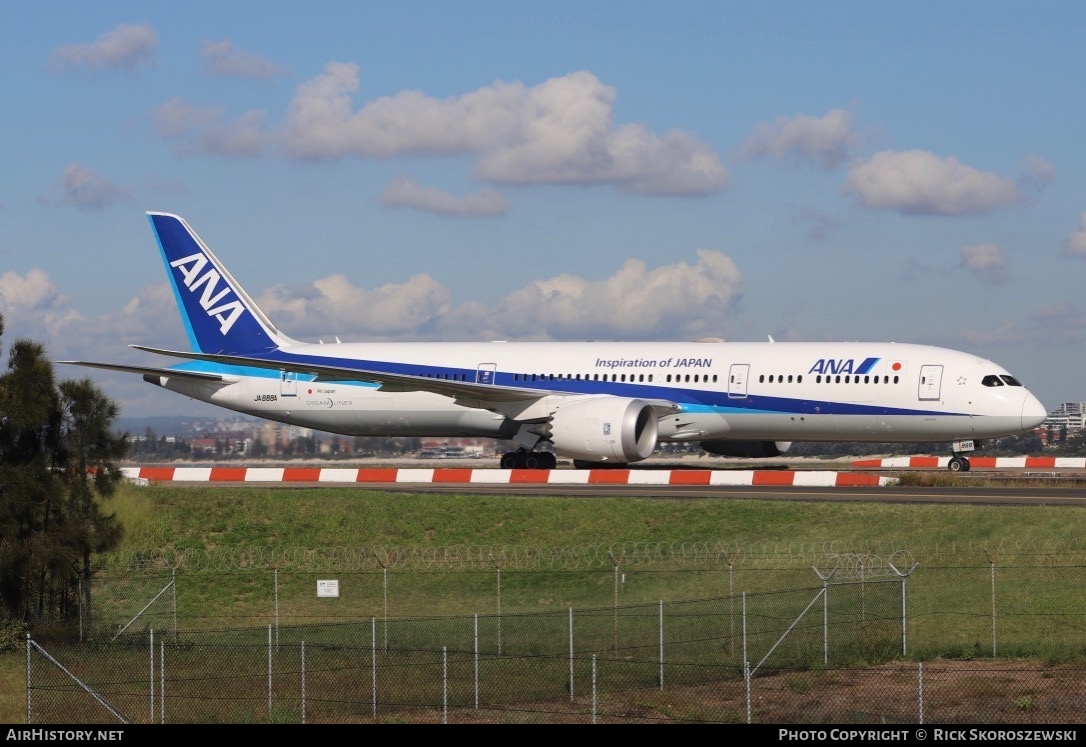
[286, 62, 728, 195]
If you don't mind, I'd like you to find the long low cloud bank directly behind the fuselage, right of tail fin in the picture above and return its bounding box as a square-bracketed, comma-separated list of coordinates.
[247, 250, 743, 340]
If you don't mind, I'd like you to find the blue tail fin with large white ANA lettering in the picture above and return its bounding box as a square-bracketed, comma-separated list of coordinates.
[148, 212, 296, 355]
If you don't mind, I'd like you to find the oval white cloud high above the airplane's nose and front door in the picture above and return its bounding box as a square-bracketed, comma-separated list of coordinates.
[844, 150, 1022, 215]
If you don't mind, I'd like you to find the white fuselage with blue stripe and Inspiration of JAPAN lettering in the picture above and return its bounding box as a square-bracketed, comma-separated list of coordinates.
[155, 342, 1046, 442]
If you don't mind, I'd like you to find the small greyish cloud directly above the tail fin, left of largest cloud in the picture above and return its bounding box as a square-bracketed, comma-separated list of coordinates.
[154, 97, 272, 156]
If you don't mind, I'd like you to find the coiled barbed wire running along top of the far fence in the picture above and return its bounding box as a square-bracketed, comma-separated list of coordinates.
[100, 539, 1086, 578]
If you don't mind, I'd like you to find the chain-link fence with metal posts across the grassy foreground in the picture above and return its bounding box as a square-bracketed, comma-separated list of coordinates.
[19, 545, 1086, 724]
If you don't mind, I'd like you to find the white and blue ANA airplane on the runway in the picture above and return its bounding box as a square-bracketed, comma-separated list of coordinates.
[60, 212, 1047, 471]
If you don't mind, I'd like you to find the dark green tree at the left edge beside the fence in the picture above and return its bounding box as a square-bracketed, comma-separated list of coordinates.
[0, 318, 128, 621]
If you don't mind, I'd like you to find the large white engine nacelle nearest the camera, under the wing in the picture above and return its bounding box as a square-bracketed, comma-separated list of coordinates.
[548, 396, 659, 464]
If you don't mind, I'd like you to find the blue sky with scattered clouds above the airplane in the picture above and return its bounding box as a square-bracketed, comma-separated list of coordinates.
[0, 0, 1086, 417]
